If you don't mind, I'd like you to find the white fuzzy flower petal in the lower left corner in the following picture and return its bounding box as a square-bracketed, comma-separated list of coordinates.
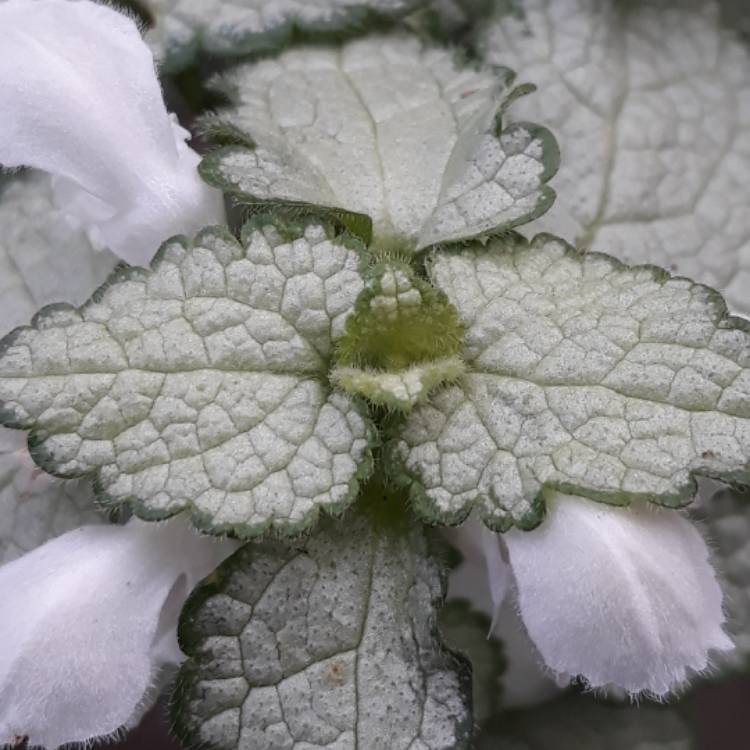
[0, 520, 235, 748]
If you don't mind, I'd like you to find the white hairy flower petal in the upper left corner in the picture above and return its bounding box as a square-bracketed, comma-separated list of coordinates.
[0, 0, 222, 264]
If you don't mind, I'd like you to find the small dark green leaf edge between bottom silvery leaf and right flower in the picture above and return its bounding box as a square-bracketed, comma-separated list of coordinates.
[438, 599, 506, 726]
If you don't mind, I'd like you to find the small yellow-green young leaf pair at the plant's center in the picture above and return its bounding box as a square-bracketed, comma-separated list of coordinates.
[331, 257, 464, 410]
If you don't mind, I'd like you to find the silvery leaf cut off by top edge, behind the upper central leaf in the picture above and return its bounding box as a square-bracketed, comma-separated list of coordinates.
[148, 0, 423, 72]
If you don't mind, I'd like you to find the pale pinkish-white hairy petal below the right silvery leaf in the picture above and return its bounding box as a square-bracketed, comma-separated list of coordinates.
[505, 494, 733, 696]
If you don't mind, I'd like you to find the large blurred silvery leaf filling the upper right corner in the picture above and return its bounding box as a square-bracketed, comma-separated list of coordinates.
[479, 0, 750, 314]
